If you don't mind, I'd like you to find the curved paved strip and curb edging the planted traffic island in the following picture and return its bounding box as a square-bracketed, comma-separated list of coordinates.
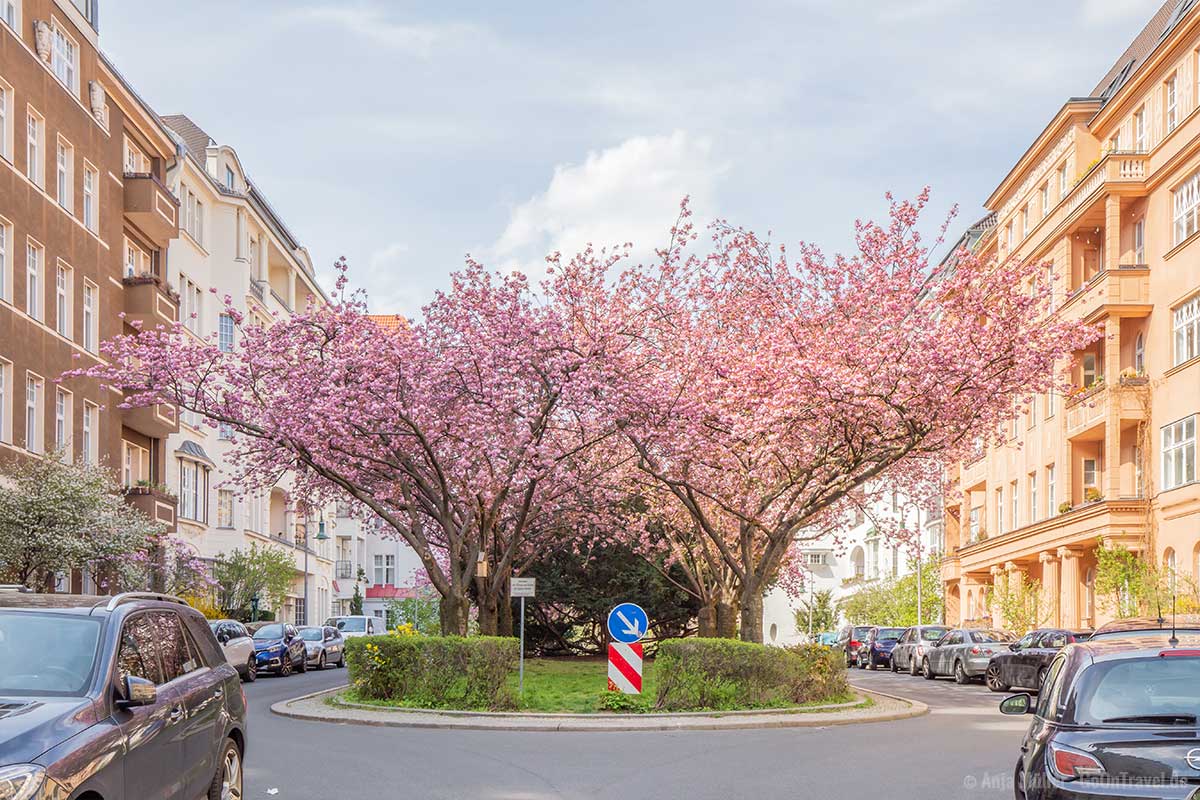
[271, 686, 929, 732]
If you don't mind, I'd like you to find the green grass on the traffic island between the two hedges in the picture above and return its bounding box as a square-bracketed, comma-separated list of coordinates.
[343, 658, 854, 714]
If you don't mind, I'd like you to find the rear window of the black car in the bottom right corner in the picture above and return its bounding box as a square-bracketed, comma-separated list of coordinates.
[1069, 656, 1200, 724]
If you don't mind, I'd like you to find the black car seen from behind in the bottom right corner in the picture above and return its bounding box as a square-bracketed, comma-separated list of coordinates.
[1000, 632, 1200, 800]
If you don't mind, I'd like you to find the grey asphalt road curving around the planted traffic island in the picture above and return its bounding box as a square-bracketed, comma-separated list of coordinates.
[245, 669, 1026, 800]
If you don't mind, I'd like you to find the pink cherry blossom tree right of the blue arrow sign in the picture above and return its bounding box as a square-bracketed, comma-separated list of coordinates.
[606, 191, 1097, 642]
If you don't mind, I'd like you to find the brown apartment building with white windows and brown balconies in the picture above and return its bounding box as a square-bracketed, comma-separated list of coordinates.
[0, 0, 179, 591]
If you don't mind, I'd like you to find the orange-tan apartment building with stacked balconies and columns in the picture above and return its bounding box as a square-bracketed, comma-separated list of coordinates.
[942, 0, 1200, 627]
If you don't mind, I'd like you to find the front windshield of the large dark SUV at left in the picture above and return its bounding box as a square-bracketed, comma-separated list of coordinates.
[0, 612, 100, 697]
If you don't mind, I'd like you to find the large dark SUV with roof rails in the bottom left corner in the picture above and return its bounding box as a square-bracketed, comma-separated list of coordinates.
[0, 591, 246, 800]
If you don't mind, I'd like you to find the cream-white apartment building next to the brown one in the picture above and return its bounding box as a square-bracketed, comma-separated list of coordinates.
[159, 115, 335, 624]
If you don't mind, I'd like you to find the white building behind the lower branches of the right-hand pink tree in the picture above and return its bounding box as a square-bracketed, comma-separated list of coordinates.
[762, 492, 942, 645]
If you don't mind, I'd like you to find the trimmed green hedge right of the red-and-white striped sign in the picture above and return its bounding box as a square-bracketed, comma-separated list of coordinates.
[654, 639, 850, 711]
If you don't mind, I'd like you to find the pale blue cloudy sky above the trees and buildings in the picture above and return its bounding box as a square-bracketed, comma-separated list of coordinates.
[100, 0, 1162, 315]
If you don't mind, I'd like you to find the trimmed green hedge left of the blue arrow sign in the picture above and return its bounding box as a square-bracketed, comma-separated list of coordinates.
[346, 634, 518, 709]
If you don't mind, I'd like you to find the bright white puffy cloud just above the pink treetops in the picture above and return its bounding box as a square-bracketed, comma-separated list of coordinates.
[488, 131, 726, 275]
